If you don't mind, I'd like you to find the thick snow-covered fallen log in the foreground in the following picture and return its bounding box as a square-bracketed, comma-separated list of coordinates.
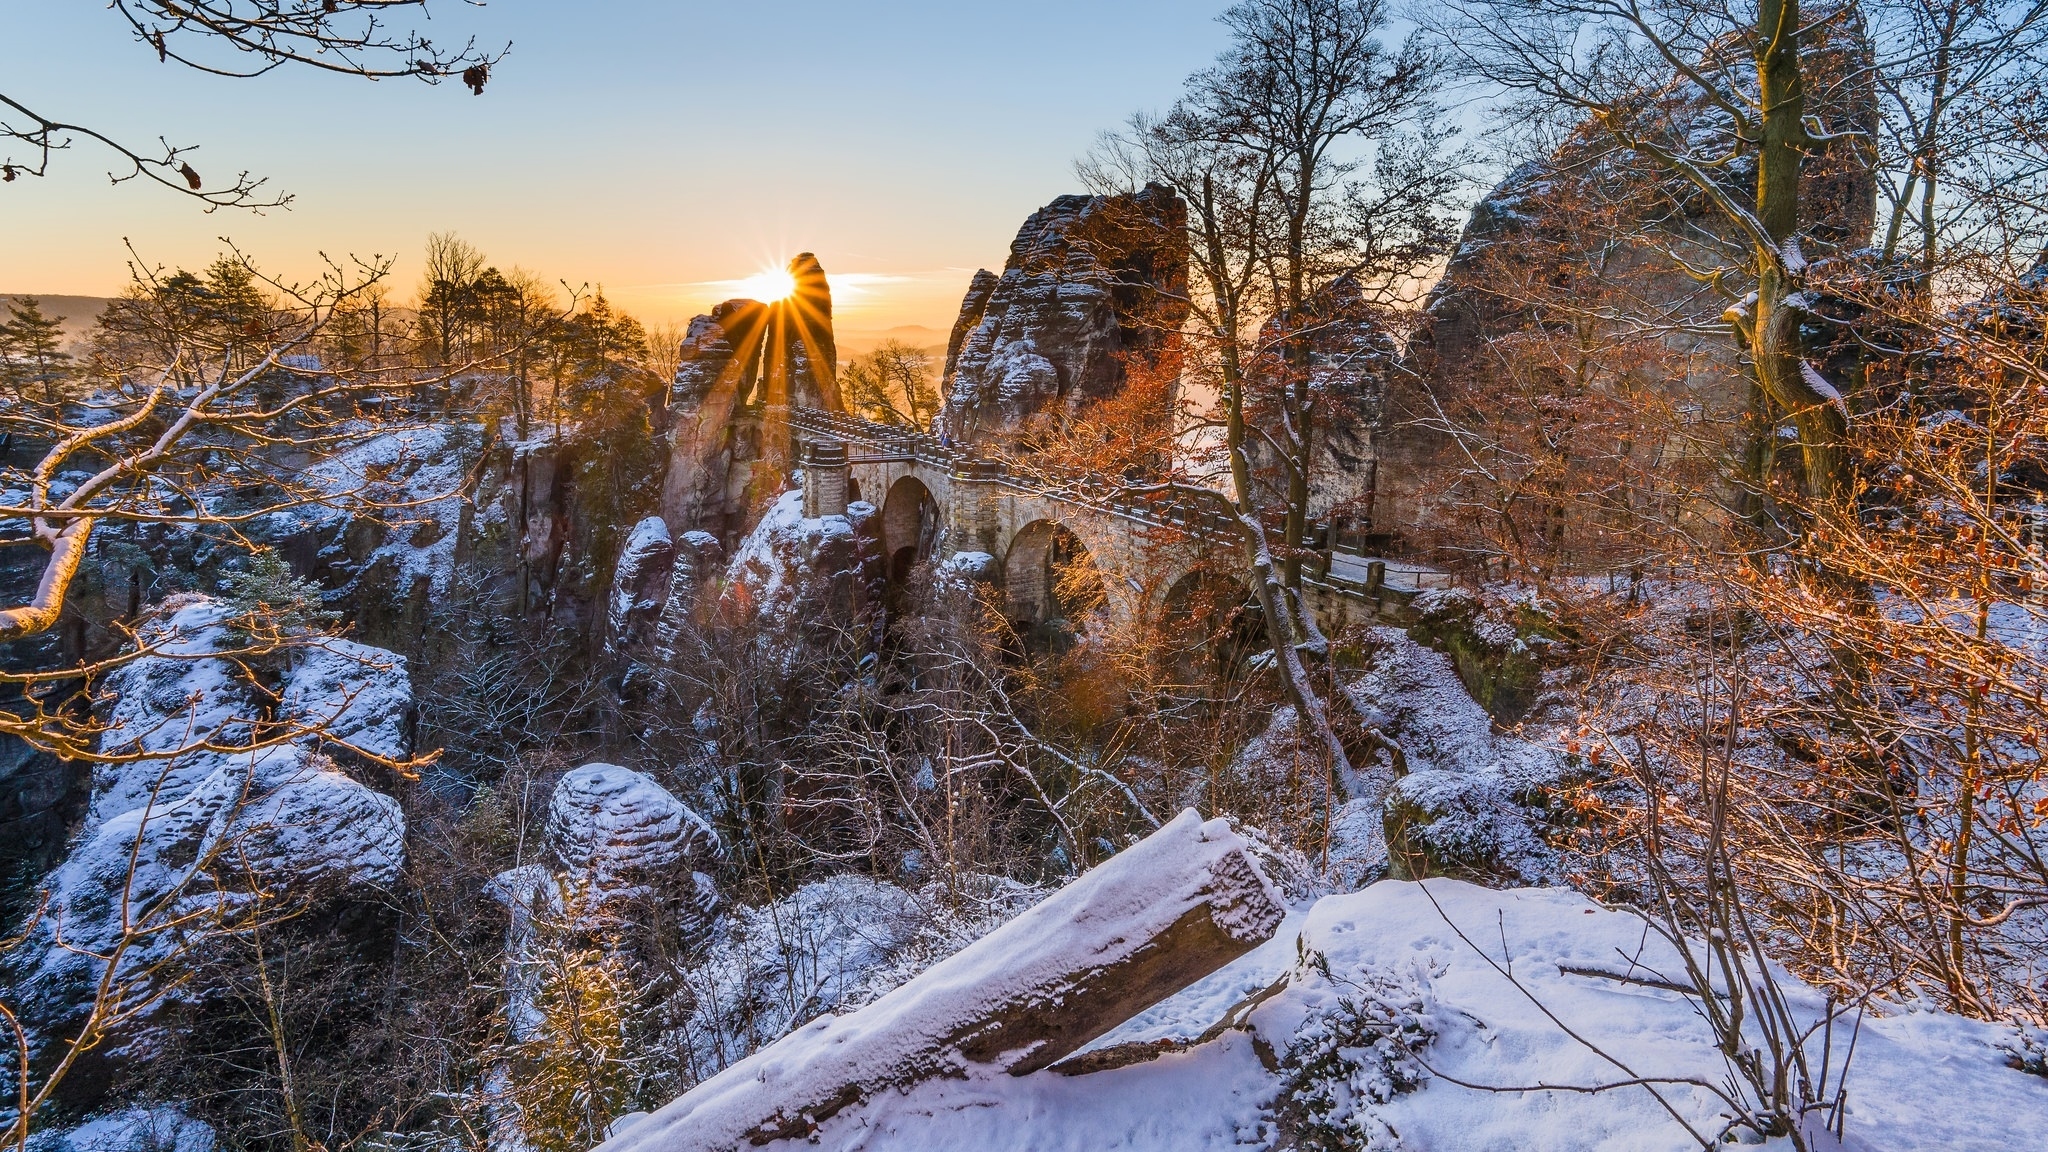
[602, 810, 1282, 1152]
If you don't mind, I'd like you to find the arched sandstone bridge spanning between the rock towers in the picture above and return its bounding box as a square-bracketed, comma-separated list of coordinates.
[764, 408, 1415, 631]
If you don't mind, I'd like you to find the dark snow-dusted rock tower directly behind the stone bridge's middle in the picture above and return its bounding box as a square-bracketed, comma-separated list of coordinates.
[940, 184, 1188, 443]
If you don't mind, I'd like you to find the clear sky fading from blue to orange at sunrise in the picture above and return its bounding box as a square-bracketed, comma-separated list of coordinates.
[0, 0, 1225, 330]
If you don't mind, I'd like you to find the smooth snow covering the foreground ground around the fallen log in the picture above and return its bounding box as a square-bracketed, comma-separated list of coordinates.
[655, 879, 2048, 1152]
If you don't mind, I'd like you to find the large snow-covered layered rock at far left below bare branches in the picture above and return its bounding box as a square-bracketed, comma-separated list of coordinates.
[6, 596, 414, 1054]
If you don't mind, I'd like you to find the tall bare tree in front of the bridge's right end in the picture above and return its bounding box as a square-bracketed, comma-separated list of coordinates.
[1081, 0, 1454, 777]
